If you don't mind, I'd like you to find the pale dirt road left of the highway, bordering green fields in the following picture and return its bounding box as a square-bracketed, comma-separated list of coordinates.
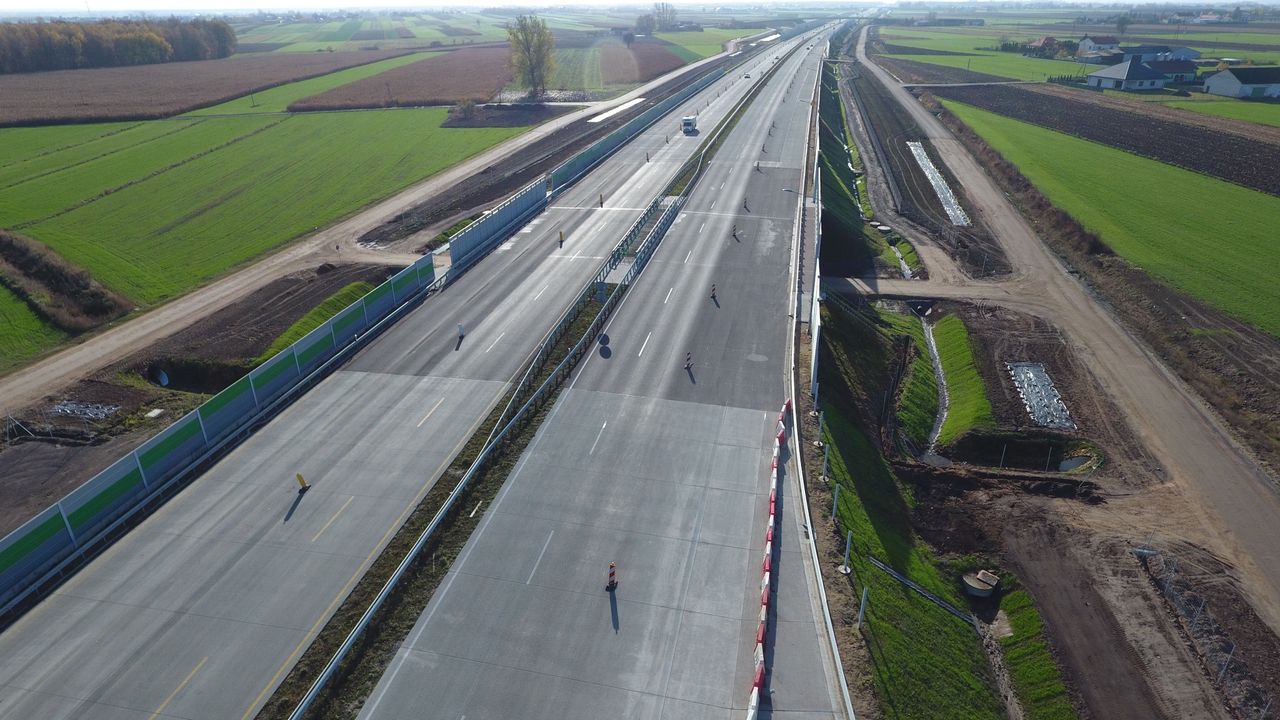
[0, 49, 737, 410]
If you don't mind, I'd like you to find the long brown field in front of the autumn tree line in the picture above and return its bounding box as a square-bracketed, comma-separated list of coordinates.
[0, 50, 410, 127]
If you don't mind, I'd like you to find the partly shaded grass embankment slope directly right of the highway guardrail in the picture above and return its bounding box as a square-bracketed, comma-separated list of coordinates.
[819, 299, 1002, 720]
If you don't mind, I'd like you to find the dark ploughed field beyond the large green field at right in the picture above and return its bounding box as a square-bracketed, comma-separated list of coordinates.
[932, 85, 1280, 195]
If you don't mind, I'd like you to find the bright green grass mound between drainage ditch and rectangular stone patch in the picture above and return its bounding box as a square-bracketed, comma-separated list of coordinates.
[933, 315, 996, 447]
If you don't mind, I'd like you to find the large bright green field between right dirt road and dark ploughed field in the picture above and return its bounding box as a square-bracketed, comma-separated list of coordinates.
[945, 101, 1280, 336]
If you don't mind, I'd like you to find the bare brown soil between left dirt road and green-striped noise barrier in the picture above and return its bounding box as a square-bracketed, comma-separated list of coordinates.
[0, 260, 394, 537]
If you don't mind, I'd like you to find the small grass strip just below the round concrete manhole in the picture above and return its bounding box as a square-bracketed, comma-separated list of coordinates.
[1000, 589, 1078, 720]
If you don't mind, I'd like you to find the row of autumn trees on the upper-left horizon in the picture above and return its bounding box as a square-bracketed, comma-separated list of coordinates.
[0, 18, 236, 74]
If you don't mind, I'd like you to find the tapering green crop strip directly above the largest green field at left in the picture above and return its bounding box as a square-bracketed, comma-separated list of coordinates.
[0, 117, 282, 229]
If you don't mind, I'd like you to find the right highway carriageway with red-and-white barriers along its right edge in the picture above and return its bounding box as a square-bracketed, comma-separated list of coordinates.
[361, 35, 840, 720]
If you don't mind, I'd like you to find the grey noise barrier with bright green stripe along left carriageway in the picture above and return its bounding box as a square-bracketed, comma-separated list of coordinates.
[0, 256, 440, 614]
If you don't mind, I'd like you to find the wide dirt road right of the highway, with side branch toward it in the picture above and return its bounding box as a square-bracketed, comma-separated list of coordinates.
[844, 25, 1280, 632]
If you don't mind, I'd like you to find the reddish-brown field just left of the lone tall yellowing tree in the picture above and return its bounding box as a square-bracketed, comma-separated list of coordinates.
[289, 47, 512, 111]
